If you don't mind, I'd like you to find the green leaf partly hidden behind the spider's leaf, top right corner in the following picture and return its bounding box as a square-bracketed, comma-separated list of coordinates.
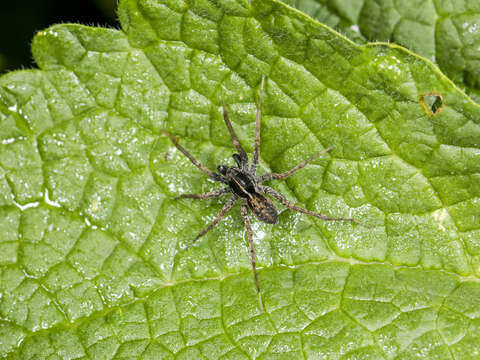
[282, 0, 480, 102]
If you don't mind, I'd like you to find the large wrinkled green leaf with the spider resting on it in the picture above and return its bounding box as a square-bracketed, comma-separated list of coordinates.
[0, 0, 480, 359]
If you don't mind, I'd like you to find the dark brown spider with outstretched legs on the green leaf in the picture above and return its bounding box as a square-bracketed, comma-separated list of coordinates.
[163, 75, 369, 312]
